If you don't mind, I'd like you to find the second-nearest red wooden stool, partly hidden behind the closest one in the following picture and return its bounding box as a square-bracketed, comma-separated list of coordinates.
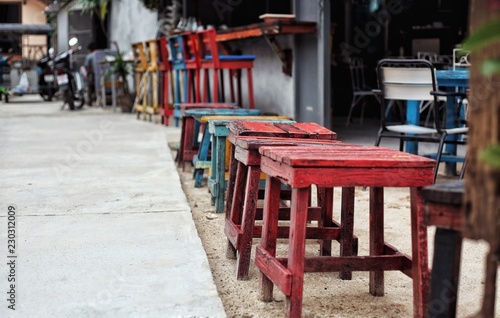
[224, 135, 357, 280]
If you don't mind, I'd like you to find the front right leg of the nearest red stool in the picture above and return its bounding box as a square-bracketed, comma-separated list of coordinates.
[410, 188, 430, 317]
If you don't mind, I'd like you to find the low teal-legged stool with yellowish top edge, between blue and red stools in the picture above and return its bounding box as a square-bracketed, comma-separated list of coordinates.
[206, 116, 294, 213]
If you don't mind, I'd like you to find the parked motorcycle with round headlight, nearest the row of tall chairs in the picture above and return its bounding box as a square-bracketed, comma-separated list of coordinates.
[54, 38, 84, 110]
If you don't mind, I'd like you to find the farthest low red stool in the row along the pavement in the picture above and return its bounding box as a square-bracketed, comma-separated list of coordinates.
[175, 103, 238, 171]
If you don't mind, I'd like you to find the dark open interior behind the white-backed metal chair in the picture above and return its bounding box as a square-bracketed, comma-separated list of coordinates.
[331, 0, 468, 117]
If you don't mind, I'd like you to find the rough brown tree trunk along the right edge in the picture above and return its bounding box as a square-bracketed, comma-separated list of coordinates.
[465, 0, 500, 257]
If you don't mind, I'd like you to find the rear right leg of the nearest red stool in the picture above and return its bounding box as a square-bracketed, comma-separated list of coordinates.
[370, 187, 384, 297]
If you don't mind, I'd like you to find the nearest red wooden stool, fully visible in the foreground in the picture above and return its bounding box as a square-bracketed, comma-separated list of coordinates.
[255, 146, 436, 317]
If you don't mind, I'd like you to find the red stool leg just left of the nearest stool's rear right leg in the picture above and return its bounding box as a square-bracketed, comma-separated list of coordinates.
[339, 187, 354, 280]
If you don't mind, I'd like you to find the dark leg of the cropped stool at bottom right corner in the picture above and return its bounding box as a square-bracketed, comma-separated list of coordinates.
[427, 228, 462, 318]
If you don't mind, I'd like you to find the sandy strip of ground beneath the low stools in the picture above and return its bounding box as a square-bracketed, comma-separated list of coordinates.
[172, 151, 500, 317]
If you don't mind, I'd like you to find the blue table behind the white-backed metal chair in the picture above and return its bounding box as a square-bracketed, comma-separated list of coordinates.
[406, 69, 469, 175]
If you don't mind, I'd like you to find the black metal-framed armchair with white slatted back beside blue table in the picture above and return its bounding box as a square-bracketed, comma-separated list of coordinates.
[375, 59, 468, 180]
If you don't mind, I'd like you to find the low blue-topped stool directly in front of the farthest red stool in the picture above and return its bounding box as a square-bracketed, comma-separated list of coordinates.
[185, 108, 260, 188]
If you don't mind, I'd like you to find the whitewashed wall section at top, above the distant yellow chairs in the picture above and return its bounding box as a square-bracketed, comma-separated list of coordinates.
[109, 0, 158, 52]
